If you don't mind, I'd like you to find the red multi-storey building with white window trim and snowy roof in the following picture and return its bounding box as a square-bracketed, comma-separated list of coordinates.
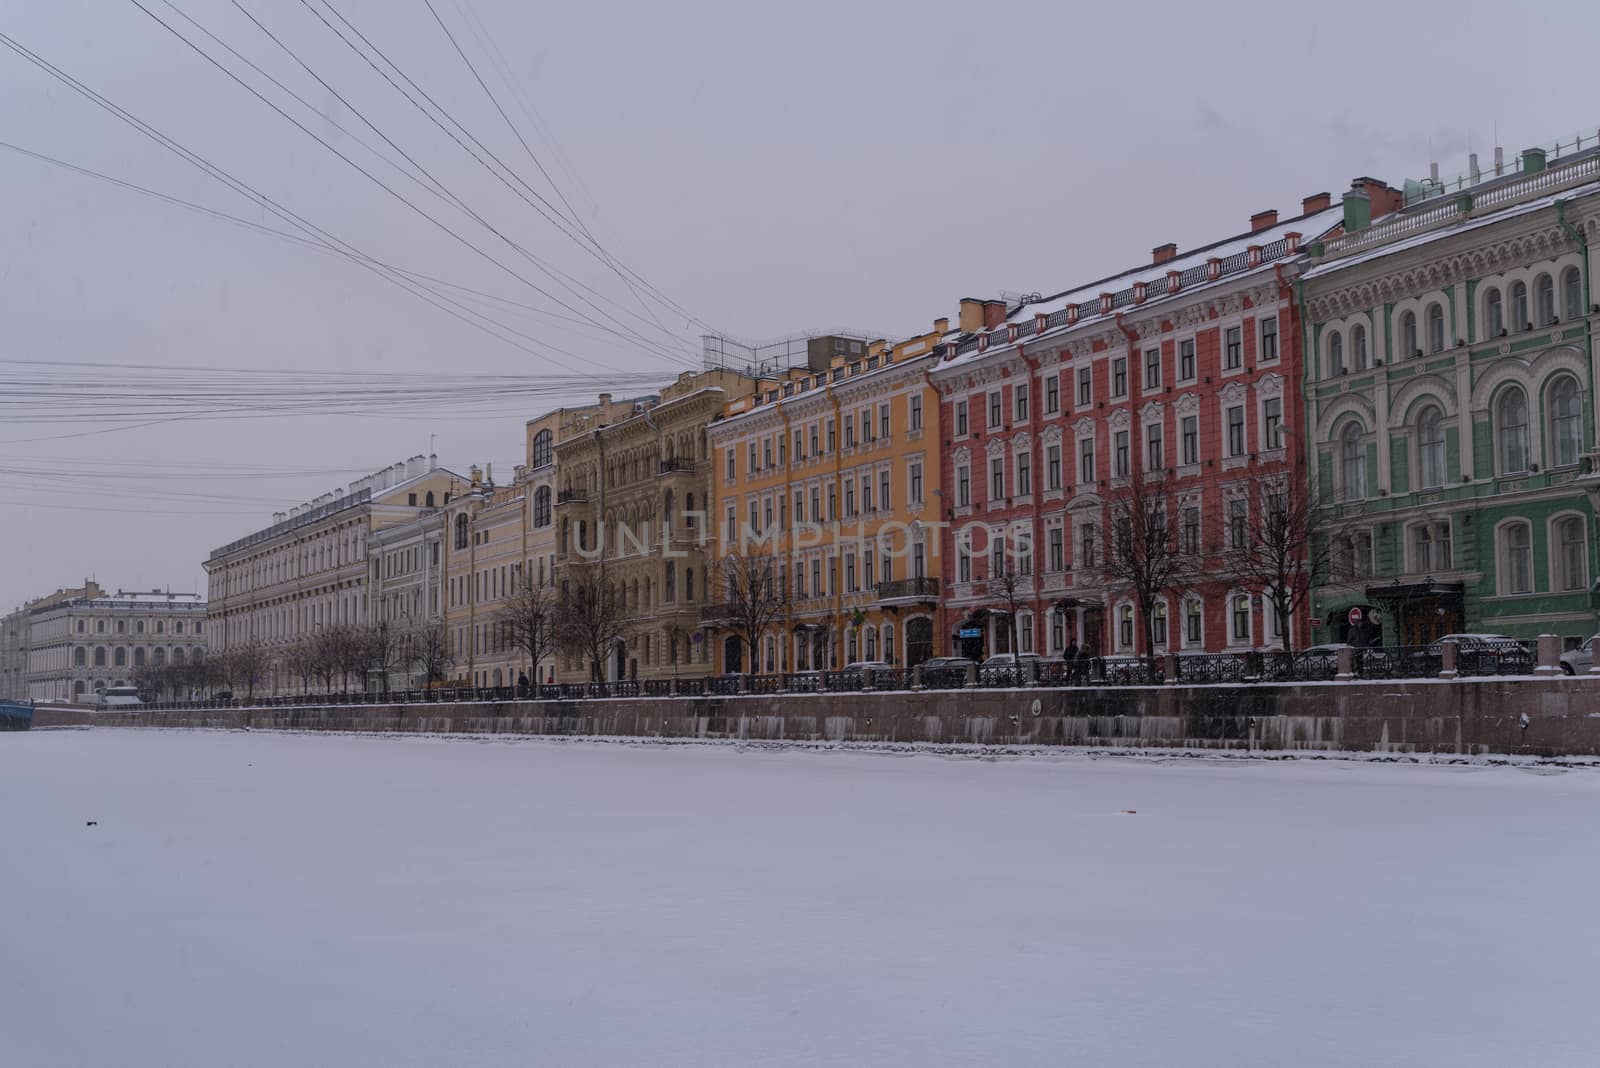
[931, 187, 1394, 656]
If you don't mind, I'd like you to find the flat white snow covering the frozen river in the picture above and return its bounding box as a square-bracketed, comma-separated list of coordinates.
[0, 729, 1600, 1068]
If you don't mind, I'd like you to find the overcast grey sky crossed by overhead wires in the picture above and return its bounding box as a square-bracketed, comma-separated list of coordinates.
[0, 0, 1600, 608]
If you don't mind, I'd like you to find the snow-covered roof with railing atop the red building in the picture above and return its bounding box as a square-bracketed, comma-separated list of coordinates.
[939, 205, 1344, 369]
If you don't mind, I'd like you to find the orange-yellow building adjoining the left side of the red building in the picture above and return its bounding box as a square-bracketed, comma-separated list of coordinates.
[704, 320, 949, 673]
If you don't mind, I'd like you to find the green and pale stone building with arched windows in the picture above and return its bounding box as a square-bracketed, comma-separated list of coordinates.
[1301, 146, 1600, 644]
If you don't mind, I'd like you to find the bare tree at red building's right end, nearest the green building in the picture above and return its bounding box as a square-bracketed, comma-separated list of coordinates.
[1222, 472, 1333, 652]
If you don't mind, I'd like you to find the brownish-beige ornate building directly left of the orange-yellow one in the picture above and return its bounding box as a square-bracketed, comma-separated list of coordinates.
[554, 368, 755, 681]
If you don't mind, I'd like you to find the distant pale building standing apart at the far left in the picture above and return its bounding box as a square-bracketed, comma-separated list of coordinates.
[15, 582, 208, 700]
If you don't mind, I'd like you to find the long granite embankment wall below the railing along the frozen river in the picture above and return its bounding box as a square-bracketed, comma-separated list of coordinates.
[35, 678, 1600, 756]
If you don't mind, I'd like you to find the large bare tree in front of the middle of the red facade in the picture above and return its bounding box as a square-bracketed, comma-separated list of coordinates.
[1104, 475, 1203, 656]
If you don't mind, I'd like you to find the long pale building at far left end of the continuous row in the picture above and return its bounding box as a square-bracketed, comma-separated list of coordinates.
[205, 456, 467, 694]
